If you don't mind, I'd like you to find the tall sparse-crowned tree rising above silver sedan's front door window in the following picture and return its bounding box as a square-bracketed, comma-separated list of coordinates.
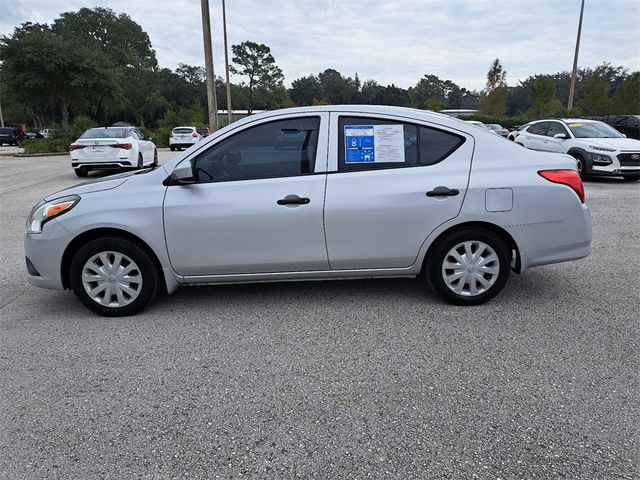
[229, 42, 284, 113]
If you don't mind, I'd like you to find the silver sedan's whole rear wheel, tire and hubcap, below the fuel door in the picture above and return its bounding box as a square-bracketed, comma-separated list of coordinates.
[426, 228, 511, 305]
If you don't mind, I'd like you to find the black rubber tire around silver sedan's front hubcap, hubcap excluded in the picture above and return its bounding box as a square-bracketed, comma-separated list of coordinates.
[69, 237, 160, 317]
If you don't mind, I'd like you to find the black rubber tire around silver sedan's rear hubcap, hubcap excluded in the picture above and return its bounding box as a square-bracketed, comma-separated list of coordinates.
[425, 227, 511, 305]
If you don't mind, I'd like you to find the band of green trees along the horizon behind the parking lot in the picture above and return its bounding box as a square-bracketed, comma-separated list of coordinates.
[0, 7, 640, 129]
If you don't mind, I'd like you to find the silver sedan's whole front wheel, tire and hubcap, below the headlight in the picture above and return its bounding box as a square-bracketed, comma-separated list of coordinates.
[69, 237, 160, 317]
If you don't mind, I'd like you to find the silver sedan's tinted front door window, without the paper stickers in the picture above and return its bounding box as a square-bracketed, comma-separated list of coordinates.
[193, 117, 320, 182]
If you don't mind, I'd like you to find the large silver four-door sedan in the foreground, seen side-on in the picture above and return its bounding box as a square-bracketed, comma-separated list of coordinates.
[25, 106, 591, 315]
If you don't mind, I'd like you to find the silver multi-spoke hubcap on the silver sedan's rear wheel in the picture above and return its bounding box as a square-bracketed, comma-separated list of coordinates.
[442, 241, 500, 297]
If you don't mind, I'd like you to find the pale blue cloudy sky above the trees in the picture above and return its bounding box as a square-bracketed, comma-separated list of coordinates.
[0, 0, 640, 89]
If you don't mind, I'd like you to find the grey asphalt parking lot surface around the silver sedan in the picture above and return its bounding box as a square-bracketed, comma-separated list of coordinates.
[0, 151, 640, 479]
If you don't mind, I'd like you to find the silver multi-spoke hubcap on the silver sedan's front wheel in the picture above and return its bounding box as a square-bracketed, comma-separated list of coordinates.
[82, 251, 142, 308]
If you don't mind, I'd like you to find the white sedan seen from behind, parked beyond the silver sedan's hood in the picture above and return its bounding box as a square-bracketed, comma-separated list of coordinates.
[69, 127, 158, 177]
